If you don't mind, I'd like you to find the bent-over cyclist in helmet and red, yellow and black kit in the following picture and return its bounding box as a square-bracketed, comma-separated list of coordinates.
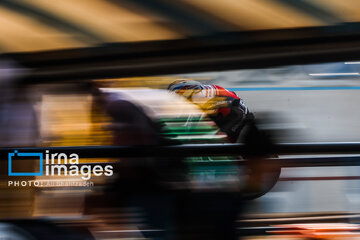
[168, 79, 281, 198]
